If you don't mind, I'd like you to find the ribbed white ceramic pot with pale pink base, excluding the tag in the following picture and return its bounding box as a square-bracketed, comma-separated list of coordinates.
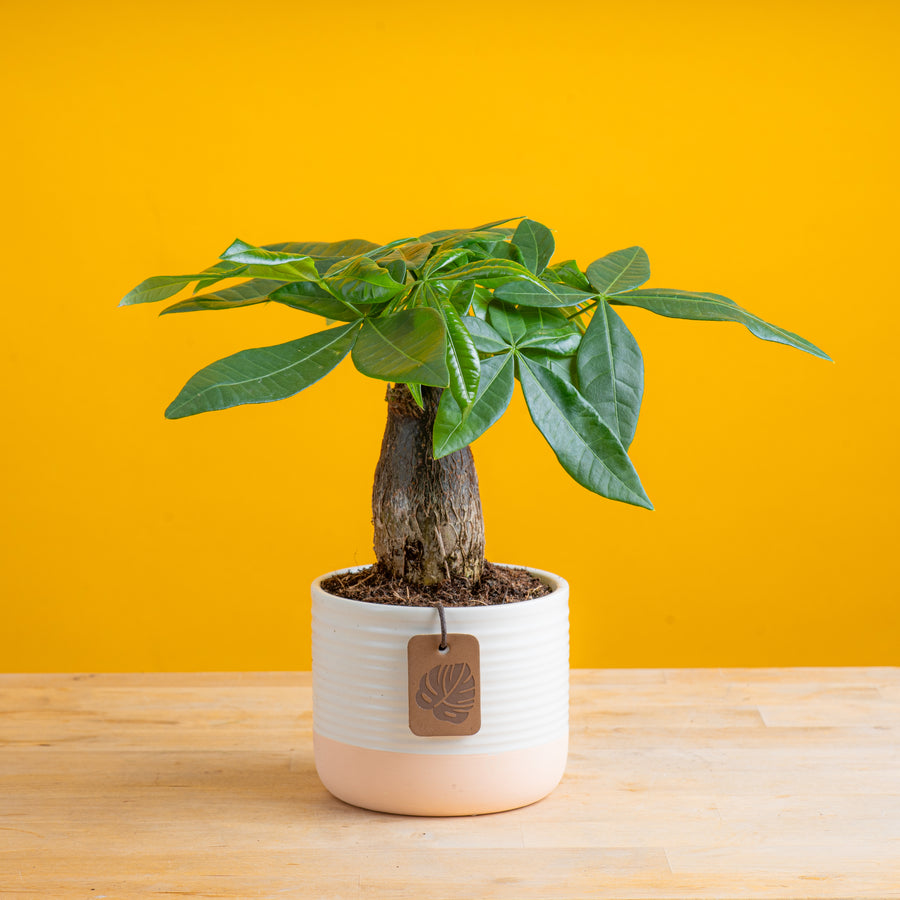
[312, 569, 569, 816]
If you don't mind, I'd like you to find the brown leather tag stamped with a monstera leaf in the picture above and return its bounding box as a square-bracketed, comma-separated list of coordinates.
[407, 634, 481, 737]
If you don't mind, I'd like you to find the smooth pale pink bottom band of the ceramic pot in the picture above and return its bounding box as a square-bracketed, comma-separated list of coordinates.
[313, 734, 569, 816]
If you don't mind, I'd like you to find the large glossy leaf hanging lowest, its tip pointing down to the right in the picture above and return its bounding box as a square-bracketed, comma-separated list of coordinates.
[517, 354, 653, 509]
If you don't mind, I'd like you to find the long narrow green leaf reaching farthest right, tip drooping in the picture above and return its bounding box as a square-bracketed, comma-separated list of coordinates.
[610, 288, 831, 360]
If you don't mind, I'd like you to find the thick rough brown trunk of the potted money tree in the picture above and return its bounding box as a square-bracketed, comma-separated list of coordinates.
[372, 384, 484, 586]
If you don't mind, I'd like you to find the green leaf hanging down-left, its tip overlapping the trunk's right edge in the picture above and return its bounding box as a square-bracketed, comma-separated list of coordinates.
[434, 353, 515, 459]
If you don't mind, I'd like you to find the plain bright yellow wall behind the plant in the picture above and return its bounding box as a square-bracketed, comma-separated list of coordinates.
[0, 0, 900, 671]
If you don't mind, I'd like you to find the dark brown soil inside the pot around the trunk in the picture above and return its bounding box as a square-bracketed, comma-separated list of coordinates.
[322, 562, 550, 606]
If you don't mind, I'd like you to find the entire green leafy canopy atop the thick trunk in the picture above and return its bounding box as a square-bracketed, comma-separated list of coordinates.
[121, 219, 828, 508]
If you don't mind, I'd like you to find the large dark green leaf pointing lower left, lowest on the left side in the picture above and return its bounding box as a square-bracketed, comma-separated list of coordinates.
[166, 323, 359, 419]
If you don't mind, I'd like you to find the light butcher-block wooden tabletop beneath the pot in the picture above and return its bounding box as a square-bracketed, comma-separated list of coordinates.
[0, 668, 900, 900]
